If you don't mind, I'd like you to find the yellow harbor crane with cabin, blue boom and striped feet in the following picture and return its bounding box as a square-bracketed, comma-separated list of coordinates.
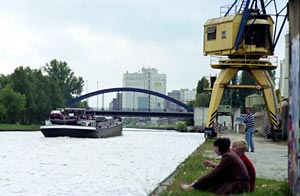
[204, 0, 287, 138]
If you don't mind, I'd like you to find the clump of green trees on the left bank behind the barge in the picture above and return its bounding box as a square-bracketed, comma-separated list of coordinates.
[0, 59, 86, 124]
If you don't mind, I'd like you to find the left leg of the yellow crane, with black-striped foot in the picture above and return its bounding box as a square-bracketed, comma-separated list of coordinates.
[205, 68, 238, 138]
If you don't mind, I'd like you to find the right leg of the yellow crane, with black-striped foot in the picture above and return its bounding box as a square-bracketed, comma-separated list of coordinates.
[249, 69, 281, 139]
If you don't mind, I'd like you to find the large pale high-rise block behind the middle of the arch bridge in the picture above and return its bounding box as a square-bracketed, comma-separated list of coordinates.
[122, 68, 166, 111]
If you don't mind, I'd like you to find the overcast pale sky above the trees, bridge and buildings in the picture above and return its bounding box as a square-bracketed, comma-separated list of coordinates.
[0, 0, 287, 105]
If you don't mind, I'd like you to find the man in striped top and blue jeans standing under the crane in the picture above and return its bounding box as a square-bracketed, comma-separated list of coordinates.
[244, 107, 255, 152]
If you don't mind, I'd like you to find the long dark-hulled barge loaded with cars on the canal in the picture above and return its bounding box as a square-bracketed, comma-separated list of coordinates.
[40, 108, 123, 138]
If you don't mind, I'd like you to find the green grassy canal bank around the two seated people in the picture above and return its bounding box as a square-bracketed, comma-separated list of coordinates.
[159, 140, 291, 196]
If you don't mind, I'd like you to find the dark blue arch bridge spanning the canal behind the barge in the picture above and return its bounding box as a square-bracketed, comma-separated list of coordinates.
[65, 87, 194, 118]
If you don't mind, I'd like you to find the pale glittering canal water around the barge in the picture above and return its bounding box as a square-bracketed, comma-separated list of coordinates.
[0, 129, 204, 196]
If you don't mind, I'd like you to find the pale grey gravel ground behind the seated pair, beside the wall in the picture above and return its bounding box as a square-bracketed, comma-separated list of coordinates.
[218, 133, 288, 180]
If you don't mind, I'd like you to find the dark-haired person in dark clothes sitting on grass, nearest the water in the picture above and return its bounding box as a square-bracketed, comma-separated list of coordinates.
[180, 138, 250, 194]
